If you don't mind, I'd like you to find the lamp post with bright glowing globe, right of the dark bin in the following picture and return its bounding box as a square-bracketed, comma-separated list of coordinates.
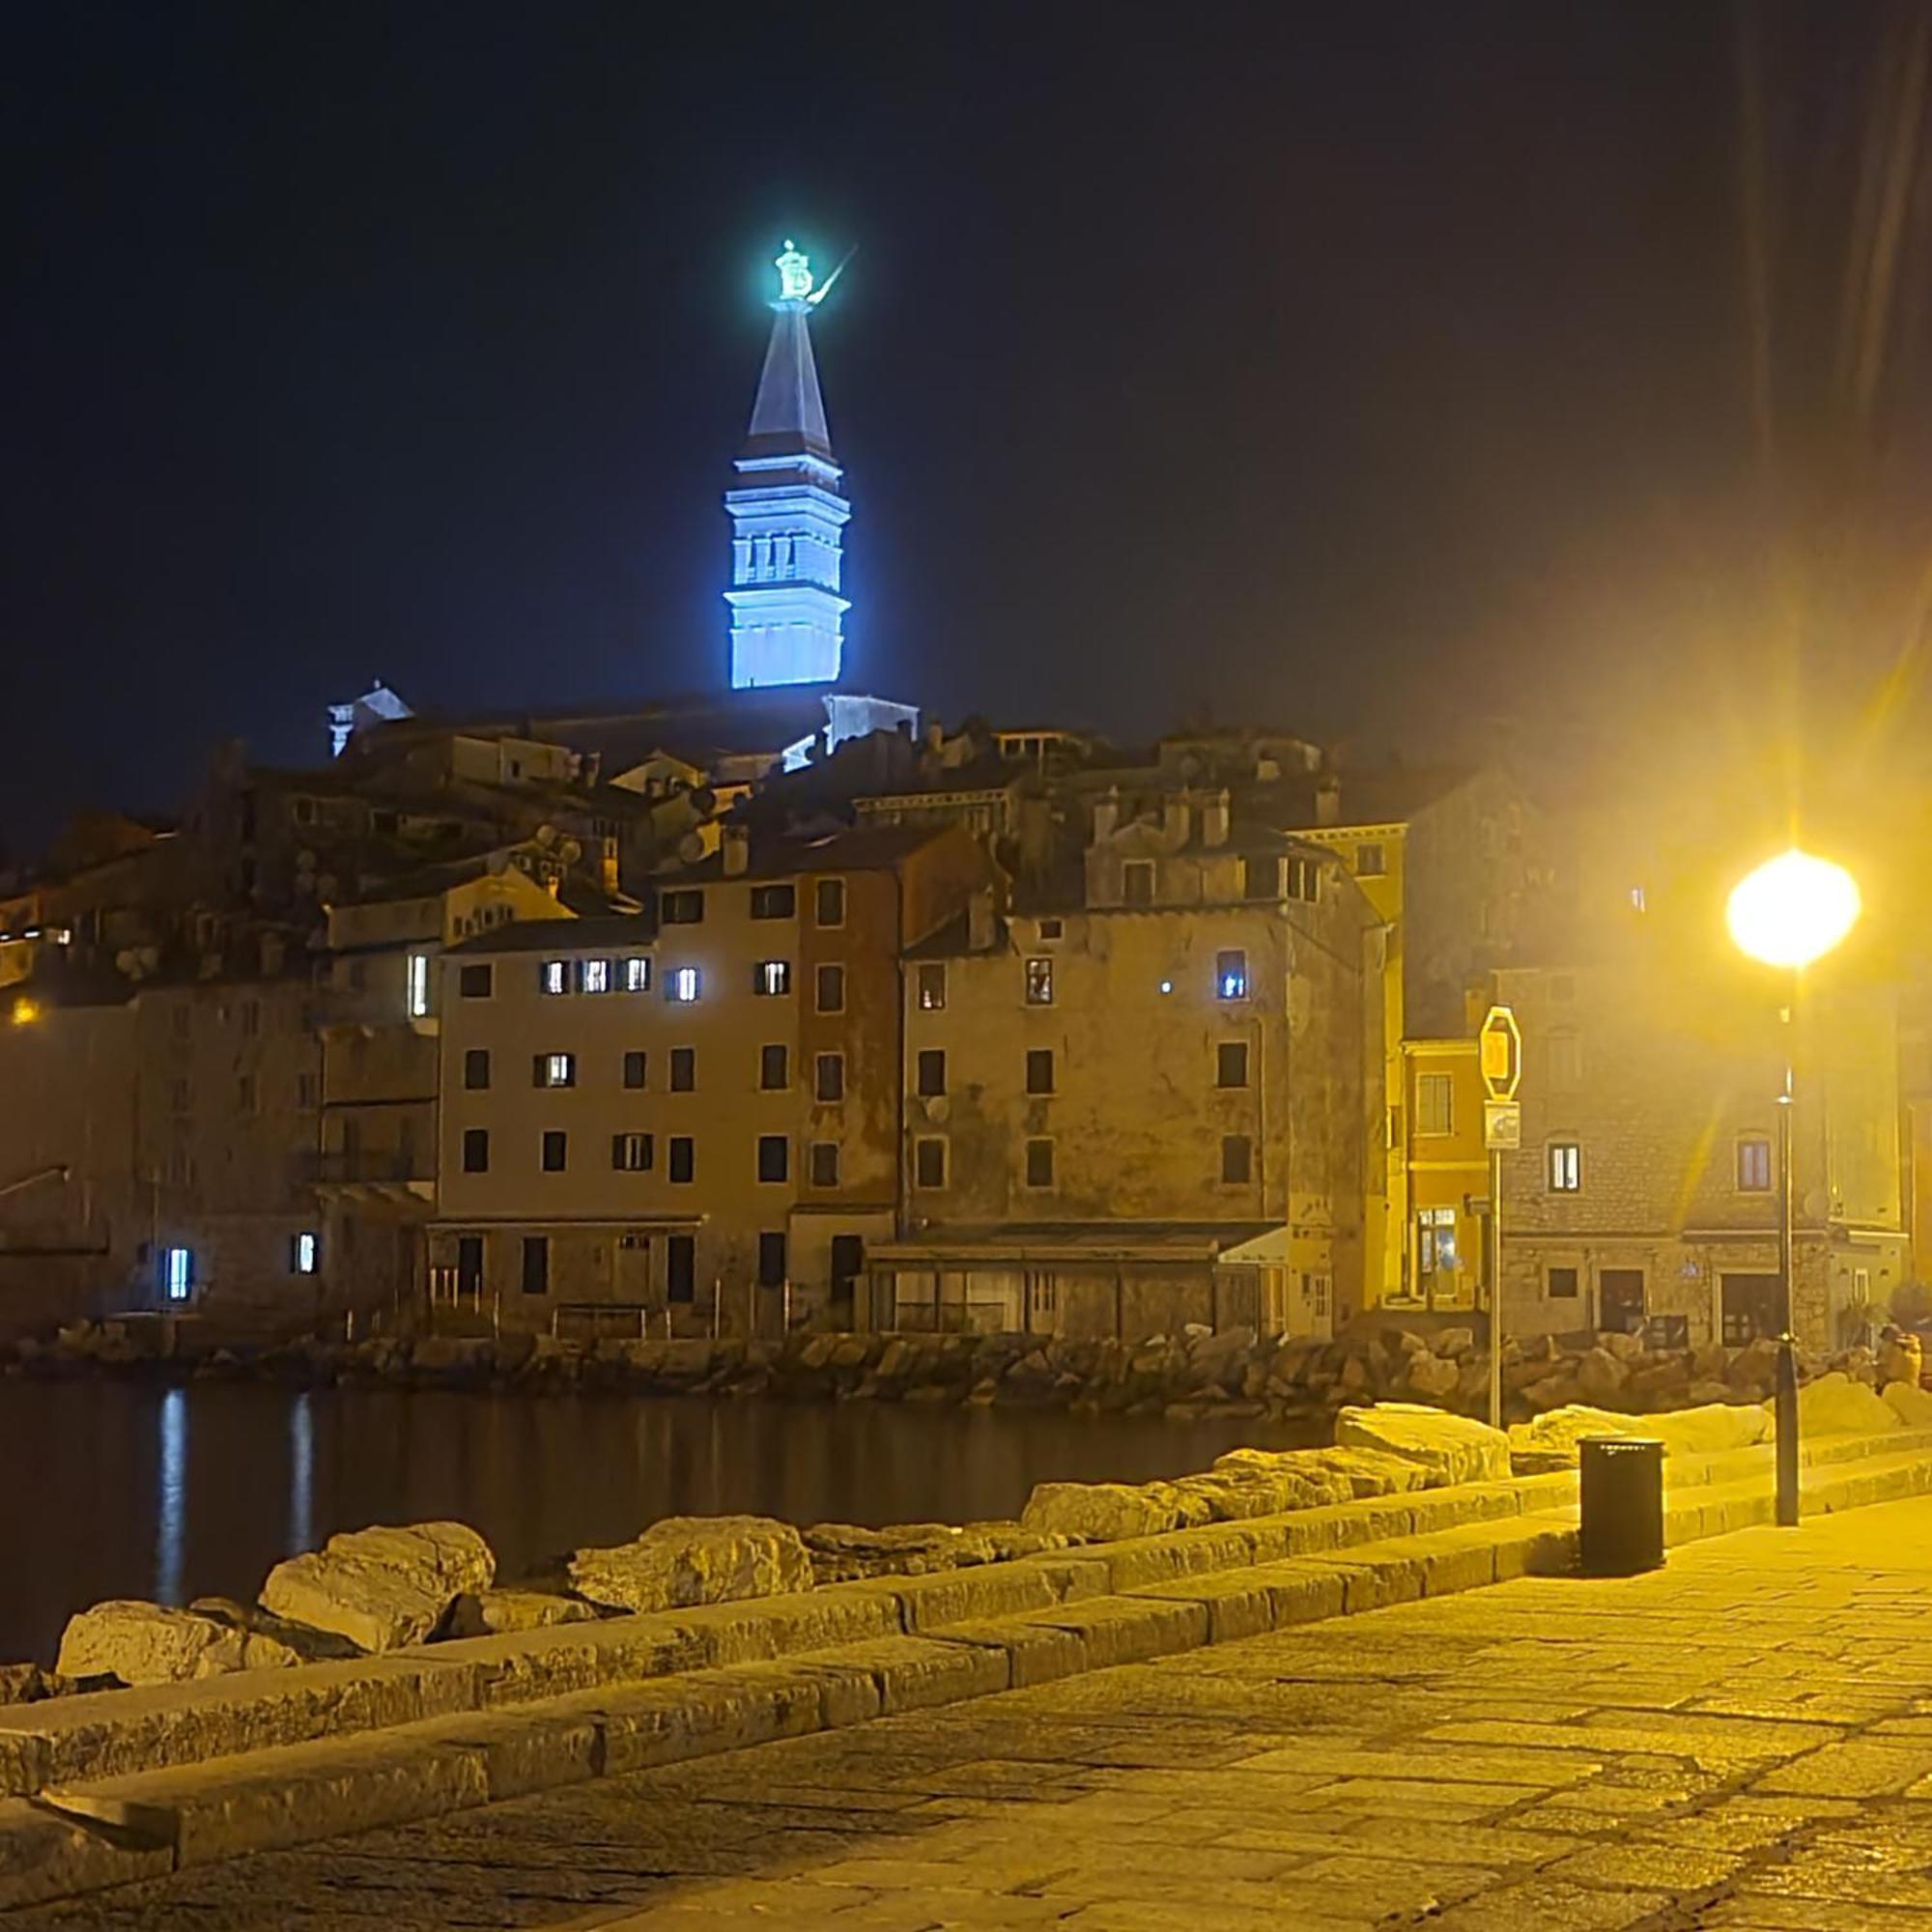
[1725, 846, 1859, 1528]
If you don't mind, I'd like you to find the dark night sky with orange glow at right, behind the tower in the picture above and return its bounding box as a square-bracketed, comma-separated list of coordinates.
[0, 0, 1932, 852]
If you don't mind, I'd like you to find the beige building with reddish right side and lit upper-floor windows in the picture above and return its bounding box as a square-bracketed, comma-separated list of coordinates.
[429, 827, 991, 1333]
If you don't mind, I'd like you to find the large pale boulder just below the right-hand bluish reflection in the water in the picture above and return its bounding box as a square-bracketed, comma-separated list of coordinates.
[261, 1522, 497, 1650]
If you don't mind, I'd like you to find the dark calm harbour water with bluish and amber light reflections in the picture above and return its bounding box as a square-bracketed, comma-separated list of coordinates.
[0, 1379, 1325, 1662]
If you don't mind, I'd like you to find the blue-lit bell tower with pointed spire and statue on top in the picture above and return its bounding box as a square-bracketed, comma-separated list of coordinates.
[724, 242, 852, 690]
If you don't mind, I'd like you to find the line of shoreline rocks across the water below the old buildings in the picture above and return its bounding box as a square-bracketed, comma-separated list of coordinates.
[18, 1314, 1917, 1420]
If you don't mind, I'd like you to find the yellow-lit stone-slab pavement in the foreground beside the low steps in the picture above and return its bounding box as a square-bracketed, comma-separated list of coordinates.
[18, 1497, 1932, 1932]
